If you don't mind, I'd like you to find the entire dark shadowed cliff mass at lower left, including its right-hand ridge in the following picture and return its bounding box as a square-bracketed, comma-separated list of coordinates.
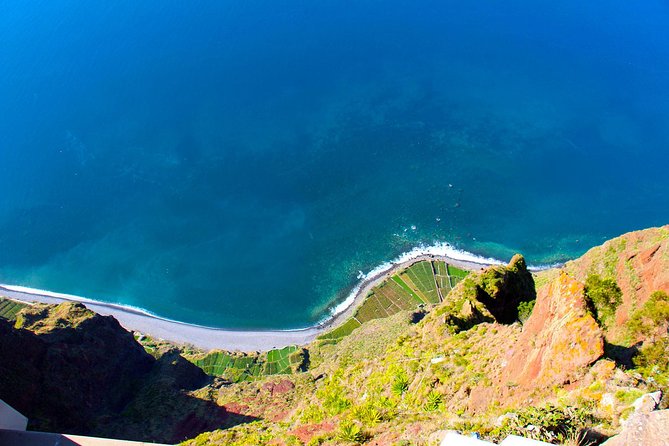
[0, 302, 235, 443]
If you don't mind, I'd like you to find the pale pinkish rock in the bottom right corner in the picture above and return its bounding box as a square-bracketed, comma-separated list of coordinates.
[602, 410, 669, 446]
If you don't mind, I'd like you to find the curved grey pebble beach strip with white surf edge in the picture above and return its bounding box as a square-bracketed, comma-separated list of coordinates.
[0, 248, 502, 352]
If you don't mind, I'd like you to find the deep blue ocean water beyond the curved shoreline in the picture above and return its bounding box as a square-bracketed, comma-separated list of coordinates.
[0, 0, 669, 328]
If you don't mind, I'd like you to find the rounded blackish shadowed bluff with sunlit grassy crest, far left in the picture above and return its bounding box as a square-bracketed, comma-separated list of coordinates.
[0, 303, 155, 433]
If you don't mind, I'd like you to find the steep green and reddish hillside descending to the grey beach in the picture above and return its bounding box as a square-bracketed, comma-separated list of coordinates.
[0, 226, 669, 445]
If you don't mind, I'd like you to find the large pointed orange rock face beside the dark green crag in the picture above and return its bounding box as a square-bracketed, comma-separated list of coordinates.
[501, 273, 604, 388]
